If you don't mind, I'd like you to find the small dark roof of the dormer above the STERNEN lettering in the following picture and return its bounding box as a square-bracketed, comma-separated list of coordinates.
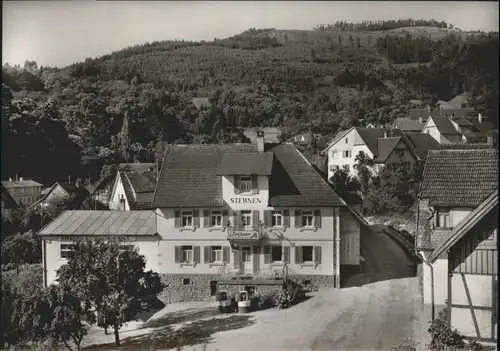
[217, 152, 274, 176]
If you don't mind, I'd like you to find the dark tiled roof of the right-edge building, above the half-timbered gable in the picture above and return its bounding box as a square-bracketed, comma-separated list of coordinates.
[420, 148, 498, 207]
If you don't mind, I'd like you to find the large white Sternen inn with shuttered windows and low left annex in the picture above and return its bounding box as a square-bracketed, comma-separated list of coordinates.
[39, 134, 365, 301]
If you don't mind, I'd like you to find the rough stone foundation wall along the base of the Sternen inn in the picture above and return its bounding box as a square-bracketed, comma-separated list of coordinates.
[158, 274, 335, 303]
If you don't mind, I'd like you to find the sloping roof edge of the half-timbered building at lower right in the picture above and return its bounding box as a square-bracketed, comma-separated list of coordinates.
[429, 188, 498, 263]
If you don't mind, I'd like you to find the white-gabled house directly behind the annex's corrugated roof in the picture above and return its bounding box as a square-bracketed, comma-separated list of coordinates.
[109, 170, 158, 211]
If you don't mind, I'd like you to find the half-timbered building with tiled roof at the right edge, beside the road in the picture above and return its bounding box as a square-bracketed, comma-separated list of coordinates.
[416, 145, 498, 341]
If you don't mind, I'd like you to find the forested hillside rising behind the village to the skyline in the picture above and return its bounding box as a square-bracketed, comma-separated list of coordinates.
[2, 22, 498, 186]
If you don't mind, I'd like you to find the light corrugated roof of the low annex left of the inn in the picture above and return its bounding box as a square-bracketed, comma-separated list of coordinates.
[38, 211, 157, 235]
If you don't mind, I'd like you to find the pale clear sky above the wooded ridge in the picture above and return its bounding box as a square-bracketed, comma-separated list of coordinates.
[2, 0, 499, 67]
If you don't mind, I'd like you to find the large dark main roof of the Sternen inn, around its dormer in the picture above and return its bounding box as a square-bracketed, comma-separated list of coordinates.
[153, 144, 346, 208]
